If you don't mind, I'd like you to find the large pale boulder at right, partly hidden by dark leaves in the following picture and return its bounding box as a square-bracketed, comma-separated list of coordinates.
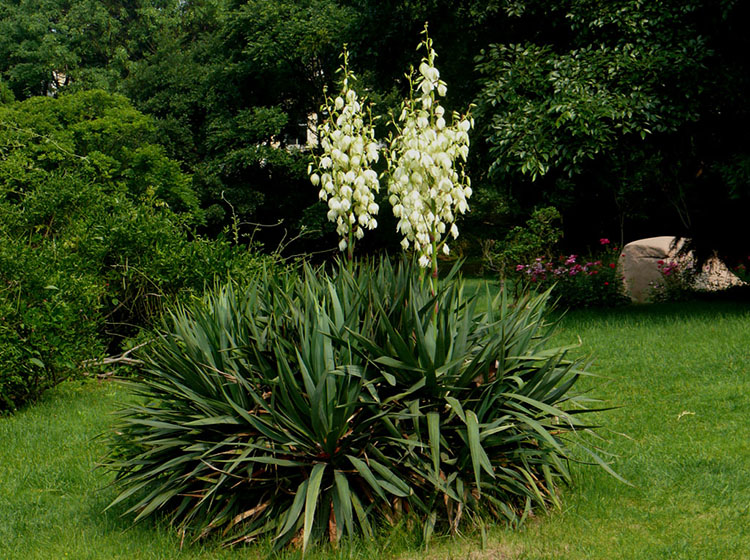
[620, 236, 742, 303]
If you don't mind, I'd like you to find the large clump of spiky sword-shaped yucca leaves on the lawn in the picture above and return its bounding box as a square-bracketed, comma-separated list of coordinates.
[106, 261, 608, 549]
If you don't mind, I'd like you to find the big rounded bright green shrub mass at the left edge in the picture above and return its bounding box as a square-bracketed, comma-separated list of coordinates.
[0, 91, 276, 410]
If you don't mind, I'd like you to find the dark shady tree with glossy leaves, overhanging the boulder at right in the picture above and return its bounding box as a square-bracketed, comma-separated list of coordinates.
[477, 0, 750, 258]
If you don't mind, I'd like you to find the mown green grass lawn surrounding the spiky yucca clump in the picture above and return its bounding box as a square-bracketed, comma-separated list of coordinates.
[0, 296, 750, 560]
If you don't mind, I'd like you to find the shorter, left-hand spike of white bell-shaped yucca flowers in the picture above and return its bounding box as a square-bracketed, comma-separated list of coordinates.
[308, 50, 380, 256]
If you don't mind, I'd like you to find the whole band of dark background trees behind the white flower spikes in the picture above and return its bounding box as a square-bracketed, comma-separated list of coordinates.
[0, 0, 750, 262]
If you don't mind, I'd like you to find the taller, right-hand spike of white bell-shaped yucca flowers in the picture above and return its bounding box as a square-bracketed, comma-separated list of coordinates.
[388, 33, 474, 269]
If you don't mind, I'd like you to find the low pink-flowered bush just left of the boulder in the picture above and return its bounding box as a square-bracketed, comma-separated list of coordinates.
[515, 238, 627, 307]
